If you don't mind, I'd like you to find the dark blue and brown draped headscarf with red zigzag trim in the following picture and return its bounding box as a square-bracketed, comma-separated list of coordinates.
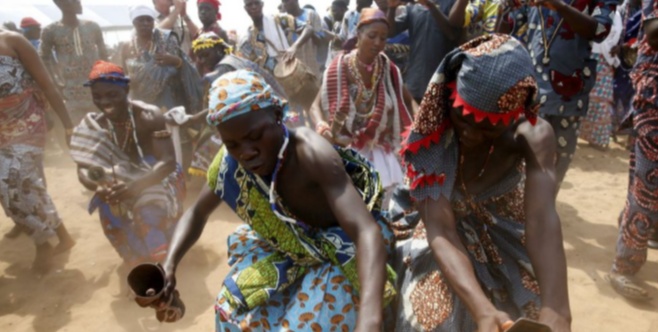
[401, 34, 539, 200]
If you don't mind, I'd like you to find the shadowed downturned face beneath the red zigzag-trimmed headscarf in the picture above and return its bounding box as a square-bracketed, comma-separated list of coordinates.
[450, 106, 509, 148]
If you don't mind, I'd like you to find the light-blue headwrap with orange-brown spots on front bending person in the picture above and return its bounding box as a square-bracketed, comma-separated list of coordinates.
[206, 69, 288, 126]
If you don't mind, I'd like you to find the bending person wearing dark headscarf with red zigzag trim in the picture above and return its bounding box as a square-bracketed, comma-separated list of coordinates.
[396, 34, 571, 332]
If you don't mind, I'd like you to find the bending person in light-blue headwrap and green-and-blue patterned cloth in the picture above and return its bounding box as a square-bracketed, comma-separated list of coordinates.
[164, 70, 395, 331]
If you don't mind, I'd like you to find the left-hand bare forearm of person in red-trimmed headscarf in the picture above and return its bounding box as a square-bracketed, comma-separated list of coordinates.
[417, 196, 510, 332]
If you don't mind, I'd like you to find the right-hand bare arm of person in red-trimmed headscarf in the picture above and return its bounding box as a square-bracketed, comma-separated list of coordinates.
[519, 119, 571, 332]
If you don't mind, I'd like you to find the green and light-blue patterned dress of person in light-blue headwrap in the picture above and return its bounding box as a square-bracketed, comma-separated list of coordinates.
[208, 148, 395, 332]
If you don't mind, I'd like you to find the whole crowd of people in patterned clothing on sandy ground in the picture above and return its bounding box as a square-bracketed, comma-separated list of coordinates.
[0, 0, 658, 332]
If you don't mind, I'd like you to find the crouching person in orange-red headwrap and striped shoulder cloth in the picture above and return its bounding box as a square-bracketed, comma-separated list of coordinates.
[71, 61, 185, 267]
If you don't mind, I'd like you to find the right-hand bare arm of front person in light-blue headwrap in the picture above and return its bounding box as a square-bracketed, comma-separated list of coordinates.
[299, 133, 387, 331]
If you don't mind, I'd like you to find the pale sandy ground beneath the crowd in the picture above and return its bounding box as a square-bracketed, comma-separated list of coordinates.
[0, 138, 658, 332]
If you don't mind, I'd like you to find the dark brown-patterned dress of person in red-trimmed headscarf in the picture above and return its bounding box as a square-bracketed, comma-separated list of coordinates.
[395, 161, 541, 332]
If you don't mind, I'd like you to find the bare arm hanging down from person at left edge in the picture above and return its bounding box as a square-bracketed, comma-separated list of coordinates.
[9, 33, 73, 131]
